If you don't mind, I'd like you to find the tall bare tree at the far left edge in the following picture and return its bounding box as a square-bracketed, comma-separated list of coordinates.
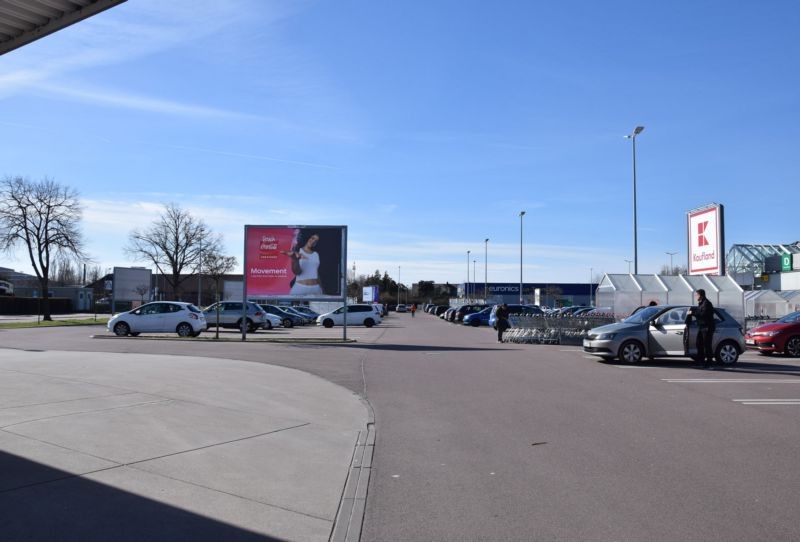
[0, 177, 86, 320]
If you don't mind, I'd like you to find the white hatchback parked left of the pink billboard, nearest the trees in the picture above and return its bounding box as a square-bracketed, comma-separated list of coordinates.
[106, 301, 208, 337]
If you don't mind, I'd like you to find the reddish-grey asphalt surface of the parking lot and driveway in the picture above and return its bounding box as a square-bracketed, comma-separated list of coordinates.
[0, 314, 800, 541]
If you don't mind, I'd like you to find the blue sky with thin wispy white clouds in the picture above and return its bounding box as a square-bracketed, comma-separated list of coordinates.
[0, 0, 800, 283]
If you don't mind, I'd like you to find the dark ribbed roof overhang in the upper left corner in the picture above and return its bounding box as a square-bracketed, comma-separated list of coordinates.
[0, 0, 126, 55]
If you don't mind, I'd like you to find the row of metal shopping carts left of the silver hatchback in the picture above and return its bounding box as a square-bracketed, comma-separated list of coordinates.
[503, 315, 617, 345]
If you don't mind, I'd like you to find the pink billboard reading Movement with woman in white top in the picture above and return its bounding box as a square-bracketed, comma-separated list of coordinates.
[244, 225, 347, 301]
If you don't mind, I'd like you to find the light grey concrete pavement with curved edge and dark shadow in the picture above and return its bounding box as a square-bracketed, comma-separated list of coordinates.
[0, 345, 374, 541]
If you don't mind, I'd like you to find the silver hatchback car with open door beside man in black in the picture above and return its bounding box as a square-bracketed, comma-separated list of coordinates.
[583, 305, 746, 365]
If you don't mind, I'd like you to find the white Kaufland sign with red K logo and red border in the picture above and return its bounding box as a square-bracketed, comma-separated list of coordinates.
[686, 203, 725, 275]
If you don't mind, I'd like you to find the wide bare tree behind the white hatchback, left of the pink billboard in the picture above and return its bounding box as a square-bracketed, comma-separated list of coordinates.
[125, 203, 222, 300]
